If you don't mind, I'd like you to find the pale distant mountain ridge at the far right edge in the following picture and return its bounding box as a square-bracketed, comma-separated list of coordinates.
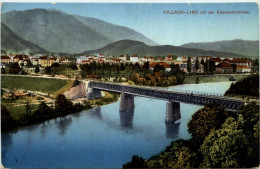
[181, 39, 259, 58]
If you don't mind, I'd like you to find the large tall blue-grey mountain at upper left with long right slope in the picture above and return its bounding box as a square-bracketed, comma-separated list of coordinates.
[1, 9, 156, 53]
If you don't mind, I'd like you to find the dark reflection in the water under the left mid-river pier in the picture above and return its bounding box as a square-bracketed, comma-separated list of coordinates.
[119, 109, 134, 128]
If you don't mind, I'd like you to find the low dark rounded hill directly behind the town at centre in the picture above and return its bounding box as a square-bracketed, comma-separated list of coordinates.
[81, 40, 245, 57]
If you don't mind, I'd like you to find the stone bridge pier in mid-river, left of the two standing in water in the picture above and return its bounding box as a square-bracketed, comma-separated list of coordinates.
[119, 93, 135, 112]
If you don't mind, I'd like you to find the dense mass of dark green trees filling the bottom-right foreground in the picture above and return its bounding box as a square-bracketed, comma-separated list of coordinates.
[123, 103, 259, 168]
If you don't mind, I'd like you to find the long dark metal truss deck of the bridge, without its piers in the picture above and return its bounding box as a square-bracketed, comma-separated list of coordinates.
[89, 81, 244, 110]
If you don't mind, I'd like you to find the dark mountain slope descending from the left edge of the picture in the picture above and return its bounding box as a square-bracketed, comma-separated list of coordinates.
[1, 23, 48, 53]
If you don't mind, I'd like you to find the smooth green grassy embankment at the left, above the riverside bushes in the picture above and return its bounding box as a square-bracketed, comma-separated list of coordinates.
[1, 76, 73, 95]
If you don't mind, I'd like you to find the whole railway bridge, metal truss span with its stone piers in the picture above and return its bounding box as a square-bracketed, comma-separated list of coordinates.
[83, 81, 244, 122]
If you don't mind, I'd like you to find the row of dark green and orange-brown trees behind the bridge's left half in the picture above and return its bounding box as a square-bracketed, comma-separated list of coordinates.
[80, 62, 185, 86]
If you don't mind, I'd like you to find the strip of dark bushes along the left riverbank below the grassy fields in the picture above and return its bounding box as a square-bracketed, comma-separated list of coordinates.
[1, 92, 118, 132]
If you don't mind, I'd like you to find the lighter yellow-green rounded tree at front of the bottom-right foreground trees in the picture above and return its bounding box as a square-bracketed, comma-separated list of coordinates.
[200, 117, 248, 168]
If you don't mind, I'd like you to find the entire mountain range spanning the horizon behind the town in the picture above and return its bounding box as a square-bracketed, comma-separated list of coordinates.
[1, 9, 259, 58]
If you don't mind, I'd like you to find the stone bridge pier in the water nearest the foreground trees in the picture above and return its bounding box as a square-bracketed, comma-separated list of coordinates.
[165, 101, 181, 123]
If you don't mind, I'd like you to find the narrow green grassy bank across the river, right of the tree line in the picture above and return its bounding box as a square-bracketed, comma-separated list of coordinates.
[183, 74, 249, 84]
